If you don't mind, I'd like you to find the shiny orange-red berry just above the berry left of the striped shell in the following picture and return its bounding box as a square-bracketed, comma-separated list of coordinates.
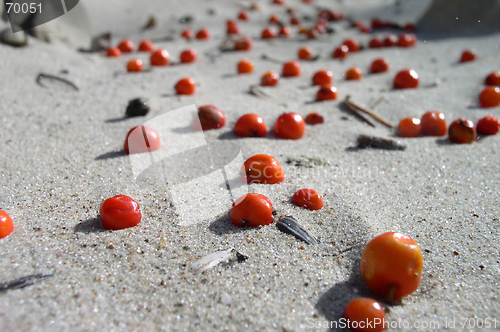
[244, 154, 285, 184]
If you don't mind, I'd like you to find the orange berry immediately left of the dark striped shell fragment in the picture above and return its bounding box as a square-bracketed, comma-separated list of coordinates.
[230, 193, 274, 227]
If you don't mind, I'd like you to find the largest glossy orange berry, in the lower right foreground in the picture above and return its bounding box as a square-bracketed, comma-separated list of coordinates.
[360, 232, 423, 301]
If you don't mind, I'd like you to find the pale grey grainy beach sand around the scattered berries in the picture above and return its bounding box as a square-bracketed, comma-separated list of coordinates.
[0, 0, 500, 332]
